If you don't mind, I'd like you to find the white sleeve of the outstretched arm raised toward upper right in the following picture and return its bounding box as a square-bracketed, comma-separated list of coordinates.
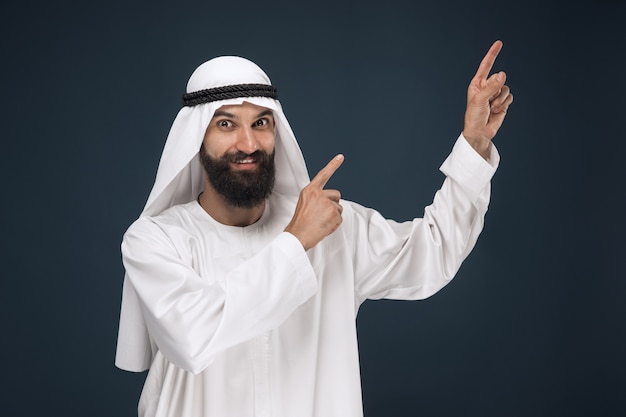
[344, 135, 499, 302]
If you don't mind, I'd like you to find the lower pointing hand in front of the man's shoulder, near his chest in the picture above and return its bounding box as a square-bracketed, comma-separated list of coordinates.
[285, 155, 344, 250]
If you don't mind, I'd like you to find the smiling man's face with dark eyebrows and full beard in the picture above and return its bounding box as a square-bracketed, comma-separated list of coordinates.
[200, 102, 275, 208]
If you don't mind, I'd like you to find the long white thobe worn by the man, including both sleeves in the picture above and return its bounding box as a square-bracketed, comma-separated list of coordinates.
[120, 137, 499, 417]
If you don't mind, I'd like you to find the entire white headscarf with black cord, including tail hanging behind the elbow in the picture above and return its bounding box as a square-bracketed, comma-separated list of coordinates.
[115, 56, 309, 371]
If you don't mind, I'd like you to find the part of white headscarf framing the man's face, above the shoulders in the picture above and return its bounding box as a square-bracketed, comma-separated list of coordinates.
[142, 56, 309, 216]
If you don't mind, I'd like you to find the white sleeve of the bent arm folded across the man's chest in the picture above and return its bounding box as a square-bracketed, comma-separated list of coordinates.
[122, 228, 317, 374]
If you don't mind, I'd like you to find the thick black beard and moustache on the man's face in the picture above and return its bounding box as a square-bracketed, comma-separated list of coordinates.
[200, 144, 276, 208]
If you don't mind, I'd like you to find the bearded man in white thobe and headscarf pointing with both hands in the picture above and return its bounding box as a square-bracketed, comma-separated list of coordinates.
[116, 41, 513, 417]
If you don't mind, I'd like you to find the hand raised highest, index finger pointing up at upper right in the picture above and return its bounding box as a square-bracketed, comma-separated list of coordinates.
[463, 41, 513, 158]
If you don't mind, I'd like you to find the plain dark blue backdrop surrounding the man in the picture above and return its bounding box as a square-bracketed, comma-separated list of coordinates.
[0, 0, 626, 417]
